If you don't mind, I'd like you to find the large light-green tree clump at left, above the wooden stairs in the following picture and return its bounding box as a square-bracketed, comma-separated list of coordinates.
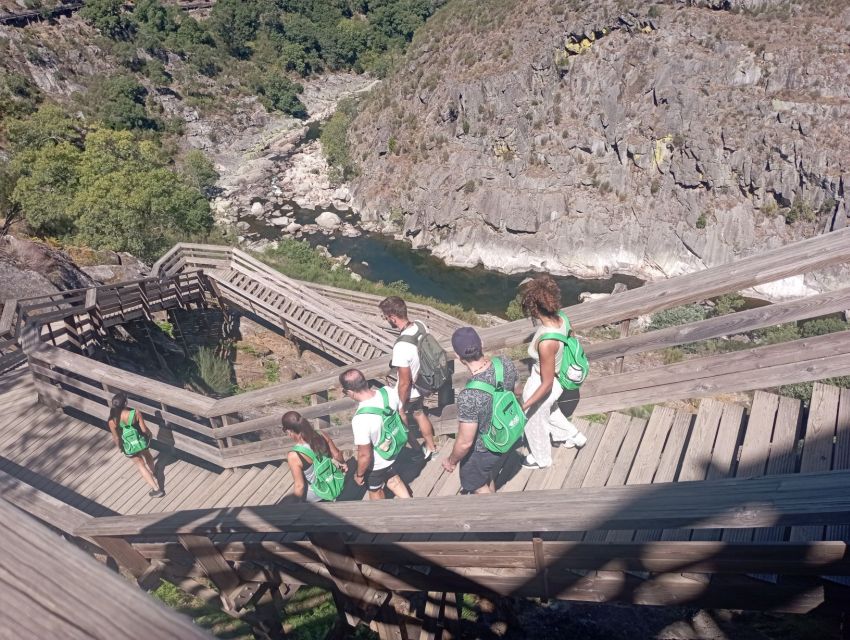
[7, 105, 212, 259]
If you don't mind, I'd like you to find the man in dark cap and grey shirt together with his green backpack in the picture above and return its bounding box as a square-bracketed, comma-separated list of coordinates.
[443, 327, 526, 493]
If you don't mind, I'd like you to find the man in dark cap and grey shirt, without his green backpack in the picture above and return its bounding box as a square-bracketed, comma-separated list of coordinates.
[443, 327, 517, 493]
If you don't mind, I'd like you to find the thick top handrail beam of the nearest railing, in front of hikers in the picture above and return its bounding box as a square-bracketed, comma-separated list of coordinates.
[76, 464, 850, 539]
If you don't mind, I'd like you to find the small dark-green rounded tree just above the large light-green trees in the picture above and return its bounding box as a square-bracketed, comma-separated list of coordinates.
[85, 75, 161, 131]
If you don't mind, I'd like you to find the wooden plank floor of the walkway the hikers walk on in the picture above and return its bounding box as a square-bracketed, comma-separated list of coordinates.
[0, 360, 850, 576]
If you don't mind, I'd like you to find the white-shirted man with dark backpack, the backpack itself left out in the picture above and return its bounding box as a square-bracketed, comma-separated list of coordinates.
[378, 296, 437, 460]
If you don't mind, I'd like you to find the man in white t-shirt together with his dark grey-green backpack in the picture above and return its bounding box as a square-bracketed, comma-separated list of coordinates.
[378, 296, 448, 460]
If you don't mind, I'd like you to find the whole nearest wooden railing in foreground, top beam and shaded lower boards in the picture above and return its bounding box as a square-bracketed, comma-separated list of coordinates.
[75, 472, 850, 612]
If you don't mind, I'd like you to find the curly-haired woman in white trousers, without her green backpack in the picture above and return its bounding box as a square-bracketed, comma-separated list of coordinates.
[520, 275, 587, 469]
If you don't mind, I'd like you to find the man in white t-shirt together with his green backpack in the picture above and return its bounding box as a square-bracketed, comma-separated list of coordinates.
[339, 369, 410, 500]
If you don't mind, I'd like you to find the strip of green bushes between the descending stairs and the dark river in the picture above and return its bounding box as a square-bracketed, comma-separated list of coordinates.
[257, 238, 478, 324]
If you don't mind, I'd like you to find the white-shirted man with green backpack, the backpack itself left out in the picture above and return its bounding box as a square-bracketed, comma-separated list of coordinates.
[339, 369, 410, 500]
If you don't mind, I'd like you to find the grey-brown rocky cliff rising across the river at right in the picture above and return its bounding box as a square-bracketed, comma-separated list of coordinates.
[349, 0, 850, 293]
